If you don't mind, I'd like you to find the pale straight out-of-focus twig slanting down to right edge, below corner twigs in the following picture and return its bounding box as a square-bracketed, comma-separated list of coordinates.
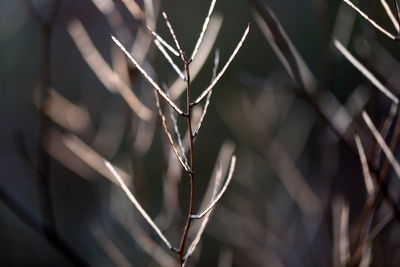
[334, 39, 399, 104]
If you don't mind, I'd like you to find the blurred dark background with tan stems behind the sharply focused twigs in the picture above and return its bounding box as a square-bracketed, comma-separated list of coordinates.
[0, 0, 400, 266]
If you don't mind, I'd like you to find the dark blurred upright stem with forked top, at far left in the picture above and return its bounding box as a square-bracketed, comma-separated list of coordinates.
[25, 0, 61, 232]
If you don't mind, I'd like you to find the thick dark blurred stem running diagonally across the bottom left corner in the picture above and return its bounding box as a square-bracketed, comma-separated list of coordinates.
[0, 185, 89, 266]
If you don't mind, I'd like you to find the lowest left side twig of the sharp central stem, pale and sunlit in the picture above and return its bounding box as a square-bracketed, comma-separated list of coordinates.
[104, 160, 173, 249]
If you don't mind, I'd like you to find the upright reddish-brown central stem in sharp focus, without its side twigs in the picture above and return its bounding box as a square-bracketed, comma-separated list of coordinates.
[178, 57, 195, 266]
